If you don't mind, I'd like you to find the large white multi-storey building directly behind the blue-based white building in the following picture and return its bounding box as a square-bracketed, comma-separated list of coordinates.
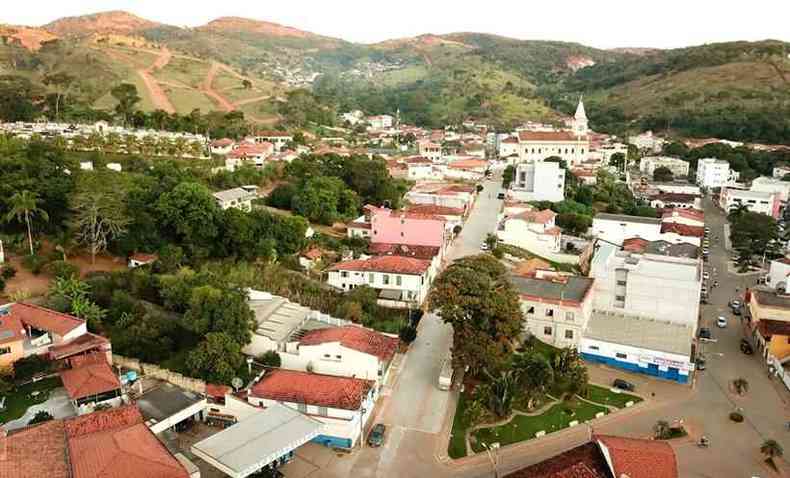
[590, 241, 702, 331]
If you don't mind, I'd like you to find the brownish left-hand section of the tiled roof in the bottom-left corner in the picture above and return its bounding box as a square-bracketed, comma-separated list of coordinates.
[0, 420, 71, 478]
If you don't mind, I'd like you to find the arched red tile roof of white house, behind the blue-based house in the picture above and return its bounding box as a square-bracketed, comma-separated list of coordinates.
[299, 325, 400, 361]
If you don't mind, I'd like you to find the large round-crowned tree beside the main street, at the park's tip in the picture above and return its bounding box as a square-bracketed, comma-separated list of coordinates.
[429, 254, 522, 375]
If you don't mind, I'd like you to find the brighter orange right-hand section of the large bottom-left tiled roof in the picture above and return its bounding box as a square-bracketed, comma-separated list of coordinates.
[65, 405, 189, 478]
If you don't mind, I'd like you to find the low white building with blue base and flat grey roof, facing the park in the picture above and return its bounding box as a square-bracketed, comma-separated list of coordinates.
[579, 310, 696, 383]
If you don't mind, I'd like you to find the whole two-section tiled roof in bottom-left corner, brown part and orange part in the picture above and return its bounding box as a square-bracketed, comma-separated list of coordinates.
[0, 405, 189, 478]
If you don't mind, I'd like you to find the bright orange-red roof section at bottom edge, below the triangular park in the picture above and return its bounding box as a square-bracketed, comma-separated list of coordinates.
[595, 435, 678, 478]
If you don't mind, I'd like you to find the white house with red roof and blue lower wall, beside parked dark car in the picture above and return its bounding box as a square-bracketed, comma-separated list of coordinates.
[247, 368, 378, 448]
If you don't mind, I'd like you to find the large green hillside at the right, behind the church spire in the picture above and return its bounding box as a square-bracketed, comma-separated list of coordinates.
[547, 41, 790, 144]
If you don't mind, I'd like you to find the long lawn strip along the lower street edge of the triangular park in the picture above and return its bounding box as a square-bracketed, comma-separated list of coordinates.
[472, 400, 606, 453]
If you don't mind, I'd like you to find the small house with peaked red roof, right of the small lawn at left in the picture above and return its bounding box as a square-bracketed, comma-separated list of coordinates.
[60, 353, 122, 415]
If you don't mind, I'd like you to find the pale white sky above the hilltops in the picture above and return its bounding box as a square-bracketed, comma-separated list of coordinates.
[0, 0, 790, 48]
